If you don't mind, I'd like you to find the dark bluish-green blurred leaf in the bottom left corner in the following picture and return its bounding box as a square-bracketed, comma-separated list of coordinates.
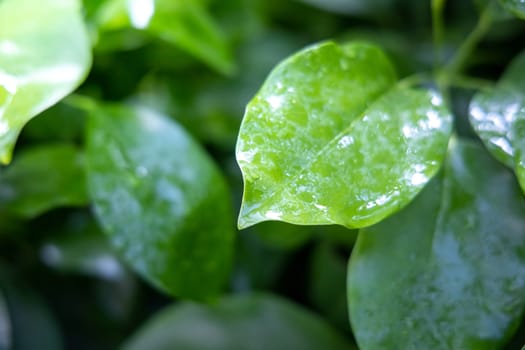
[0, 271, 63, 350]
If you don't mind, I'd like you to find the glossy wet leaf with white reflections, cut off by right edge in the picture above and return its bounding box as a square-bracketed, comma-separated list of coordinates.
[469, 51, 525, 188]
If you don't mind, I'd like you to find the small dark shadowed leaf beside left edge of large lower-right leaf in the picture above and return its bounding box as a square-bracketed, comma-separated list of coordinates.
[308, 243, 349, 330]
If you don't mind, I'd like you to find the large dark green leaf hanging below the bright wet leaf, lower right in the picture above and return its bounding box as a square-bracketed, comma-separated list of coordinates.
[348, 142, 525, 350]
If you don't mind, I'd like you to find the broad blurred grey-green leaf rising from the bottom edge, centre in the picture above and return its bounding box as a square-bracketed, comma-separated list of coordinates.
[123, 294, 352, 350]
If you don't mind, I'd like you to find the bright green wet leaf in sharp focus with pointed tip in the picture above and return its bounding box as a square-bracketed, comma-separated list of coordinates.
[236, 42, 451, 228]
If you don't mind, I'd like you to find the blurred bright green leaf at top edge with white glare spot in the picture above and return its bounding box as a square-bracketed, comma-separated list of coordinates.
[94, 0, 235, 74]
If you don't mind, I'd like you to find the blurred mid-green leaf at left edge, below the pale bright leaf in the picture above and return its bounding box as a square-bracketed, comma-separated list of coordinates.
[0, 144, 89, 219]
